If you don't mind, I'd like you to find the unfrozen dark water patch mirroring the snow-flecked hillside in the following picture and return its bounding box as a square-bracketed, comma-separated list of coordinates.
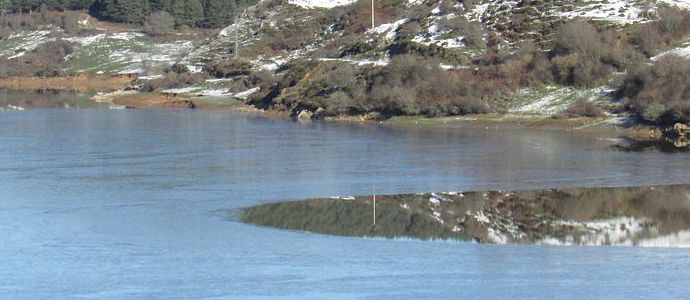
[240, 185, 690, 247]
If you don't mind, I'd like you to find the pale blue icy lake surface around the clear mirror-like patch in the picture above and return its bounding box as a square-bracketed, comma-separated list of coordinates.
[0, 110, 690, 299]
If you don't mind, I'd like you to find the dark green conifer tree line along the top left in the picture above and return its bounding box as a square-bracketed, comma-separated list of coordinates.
[0, 0, 257, 28]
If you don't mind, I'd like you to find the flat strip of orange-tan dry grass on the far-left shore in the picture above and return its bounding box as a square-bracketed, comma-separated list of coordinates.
[0, 76, 132, 92]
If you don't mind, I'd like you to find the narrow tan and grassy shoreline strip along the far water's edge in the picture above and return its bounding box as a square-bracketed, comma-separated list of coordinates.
[0, 81, 665, 143]
